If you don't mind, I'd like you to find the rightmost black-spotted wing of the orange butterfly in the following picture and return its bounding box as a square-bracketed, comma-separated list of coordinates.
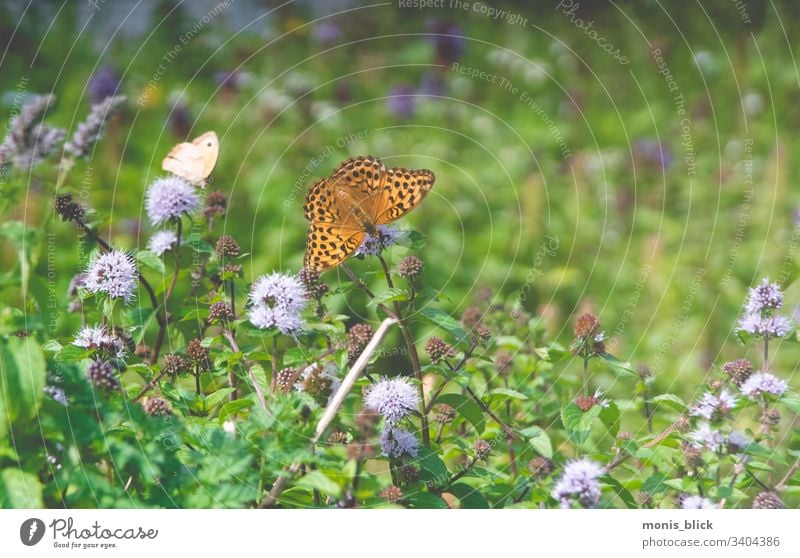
[372, 168, 436, 225]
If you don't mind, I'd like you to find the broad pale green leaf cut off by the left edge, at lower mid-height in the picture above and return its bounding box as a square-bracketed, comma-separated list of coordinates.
[0, 337, 46, 428]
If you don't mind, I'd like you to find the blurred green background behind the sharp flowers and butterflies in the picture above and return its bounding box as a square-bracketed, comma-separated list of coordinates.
[0, 0, 800, 402]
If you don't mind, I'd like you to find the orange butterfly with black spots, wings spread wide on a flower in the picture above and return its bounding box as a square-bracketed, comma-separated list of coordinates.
[303, 156, 436, 271]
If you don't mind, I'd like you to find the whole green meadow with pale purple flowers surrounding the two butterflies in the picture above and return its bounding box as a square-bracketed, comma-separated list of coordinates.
[0, 2, 800, 509]
